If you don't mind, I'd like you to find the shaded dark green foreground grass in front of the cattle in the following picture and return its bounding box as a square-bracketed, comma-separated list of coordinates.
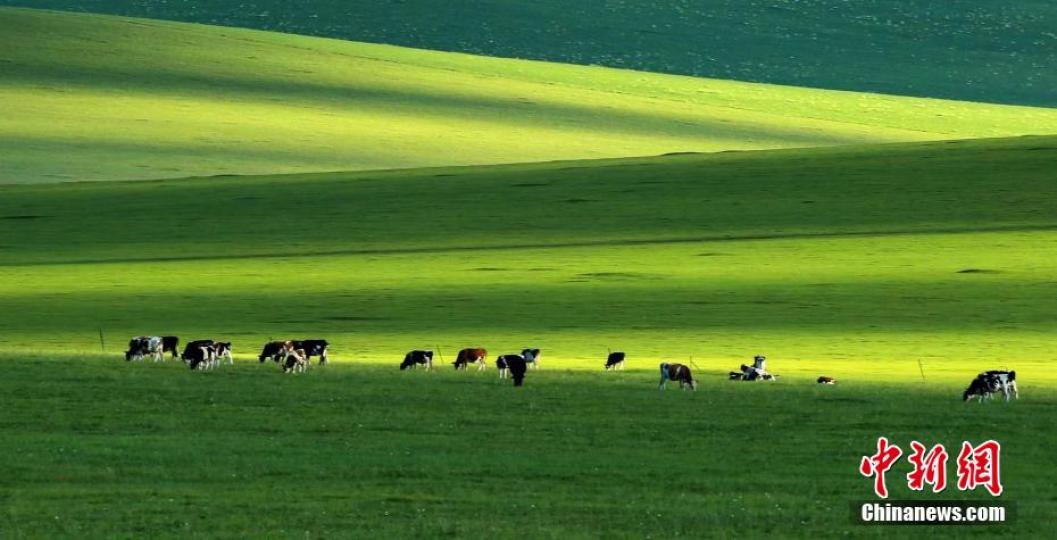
[0, 354, 1057, 539]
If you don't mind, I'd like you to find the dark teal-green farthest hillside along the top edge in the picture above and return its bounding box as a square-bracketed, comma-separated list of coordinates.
[0, 0, 1057, 107]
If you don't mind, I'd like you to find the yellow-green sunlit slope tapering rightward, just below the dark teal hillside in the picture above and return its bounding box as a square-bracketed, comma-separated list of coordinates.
[6, 8, 1057, 183]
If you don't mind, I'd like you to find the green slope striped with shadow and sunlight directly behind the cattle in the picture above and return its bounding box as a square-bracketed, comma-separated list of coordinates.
[0, 137, 1057, 387]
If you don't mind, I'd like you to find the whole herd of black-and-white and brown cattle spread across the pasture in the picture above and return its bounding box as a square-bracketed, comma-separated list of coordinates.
[125, 336, 1019, 403]
